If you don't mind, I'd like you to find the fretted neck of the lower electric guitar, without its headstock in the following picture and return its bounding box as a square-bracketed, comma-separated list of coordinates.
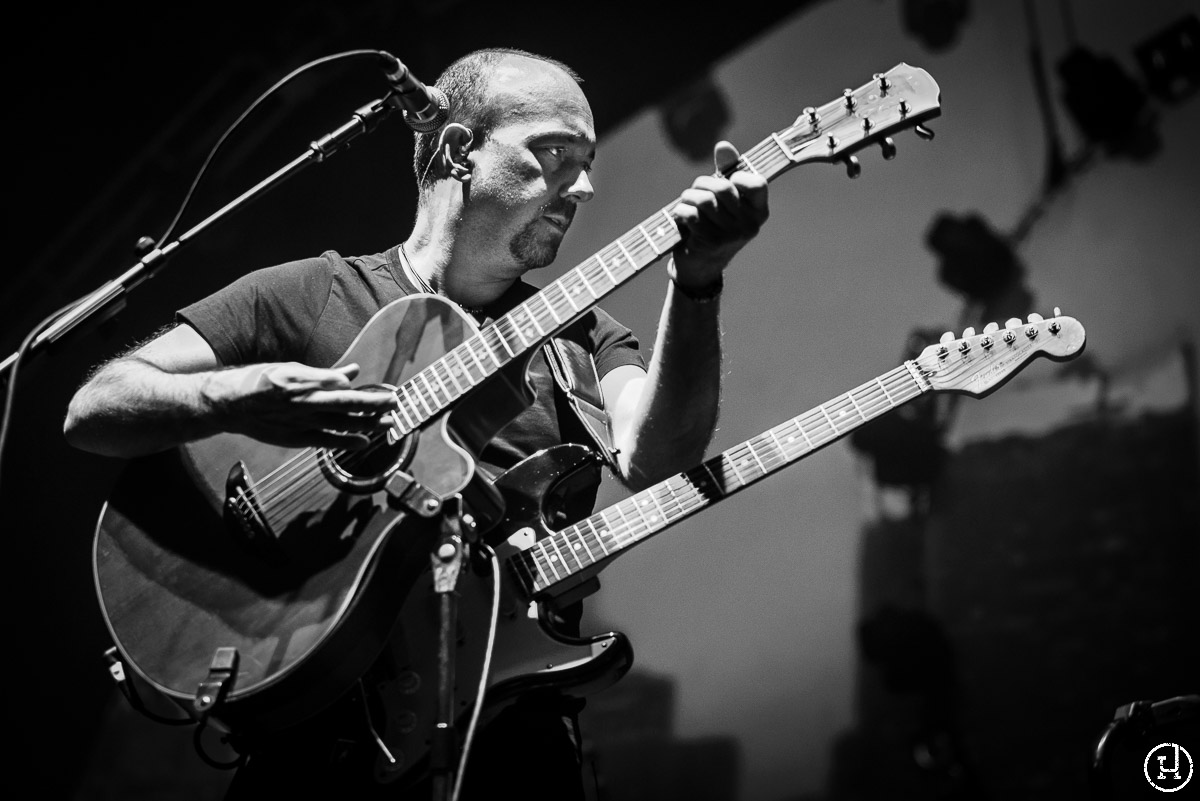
[510, 361, 930, 595]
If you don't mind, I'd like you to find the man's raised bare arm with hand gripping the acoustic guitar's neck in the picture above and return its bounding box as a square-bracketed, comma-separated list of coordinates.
[601, 143, 768, 489]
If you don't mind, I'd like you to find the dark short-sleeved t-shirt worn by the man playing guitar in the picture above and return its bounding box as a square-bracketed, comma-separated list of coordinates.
[176, 247, 646, 472]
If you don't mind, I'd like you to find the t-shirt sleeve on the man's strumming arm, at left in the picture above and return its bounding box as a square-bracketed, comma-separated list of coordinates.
[175, 255, 332, 366]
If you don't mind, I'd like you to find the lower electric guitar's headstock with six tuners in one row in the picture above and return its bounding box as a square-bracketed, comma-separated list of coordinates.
[914, 308, 1086, 397]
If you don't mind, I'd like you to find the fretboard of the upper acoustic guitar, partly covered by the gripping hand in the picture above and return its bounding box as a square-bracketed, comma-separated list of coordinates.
[384, 135, 796, 434]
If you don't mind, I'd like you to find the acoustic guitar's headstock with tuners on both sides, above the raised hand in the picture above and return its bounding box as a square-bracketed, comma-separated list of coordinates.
[775, 62, 942, 177]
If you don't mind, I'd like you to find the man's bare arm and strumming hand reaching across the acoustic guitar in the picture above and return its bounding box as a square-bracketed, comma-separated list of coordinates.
[62, 325, 396, 457]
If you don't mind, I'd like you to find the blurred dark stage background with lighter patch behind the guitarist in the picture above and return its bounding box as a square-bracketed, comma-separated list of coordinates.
[0, 0, 1200, 801]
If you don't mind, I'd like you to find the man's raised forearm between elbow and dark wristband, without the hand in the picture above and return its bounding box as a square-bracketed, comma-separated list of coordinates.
[617, 282, 721, 489]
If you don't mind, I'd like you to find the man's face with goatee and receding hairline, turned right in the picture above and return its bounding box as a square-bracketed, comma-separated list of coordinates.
[460, 58, 595, 273]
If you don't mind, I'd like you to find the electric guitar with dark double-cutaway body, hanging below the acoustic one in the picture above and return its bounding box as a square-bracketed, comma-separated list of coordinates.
[364, 309, 1085, 782]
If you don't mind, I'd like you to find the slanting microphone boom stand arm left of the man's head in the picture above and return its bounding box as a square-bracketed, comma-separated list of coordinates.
[0, 91, 403, 377]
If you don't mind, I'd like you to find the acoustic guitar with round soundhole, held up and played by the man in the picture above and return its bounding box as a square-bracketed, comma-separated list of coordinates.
[94, 64, 940, 733]
